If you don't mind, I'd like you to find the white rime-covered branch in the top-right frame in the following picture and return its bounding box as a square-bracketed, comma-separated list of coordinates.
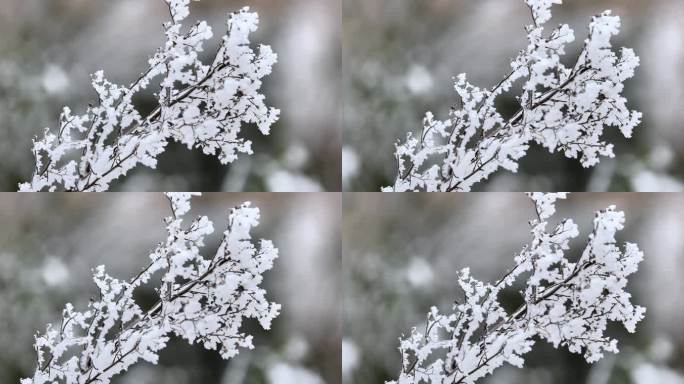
[383, 0, 641, 192]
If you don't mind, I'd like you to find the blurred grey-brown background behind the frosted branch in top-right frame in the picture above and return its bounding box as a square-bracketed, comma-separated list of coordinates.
[342, 0, 684, 192]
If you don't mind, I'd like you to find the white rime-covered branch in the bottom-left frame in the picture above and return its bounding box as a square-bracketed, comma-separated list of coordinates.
[21, 193, 280, 384]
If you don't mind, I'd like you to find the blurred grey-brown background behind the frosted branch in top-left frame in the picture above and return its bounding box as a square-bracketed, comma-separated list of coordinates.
[0, 0, 341, 191]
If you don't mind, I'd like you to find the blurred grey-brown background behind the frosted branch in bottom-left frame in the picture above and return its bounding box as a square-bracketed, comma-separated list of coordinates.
[0, 193, 342, 384]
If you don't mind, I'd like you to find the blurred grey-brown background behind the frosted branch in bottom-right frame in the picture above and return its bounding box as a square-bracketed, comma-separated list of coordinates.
[342, 193, 684, 384]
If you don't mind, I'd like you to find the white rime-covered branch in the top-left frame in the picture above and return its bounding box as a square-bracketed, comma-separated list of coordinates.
[19, 0, 280, 191]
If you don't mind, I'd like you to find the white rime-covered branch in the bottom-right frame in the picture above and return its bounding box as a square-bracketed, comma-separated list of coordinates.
[391, 193, 645, 384]
